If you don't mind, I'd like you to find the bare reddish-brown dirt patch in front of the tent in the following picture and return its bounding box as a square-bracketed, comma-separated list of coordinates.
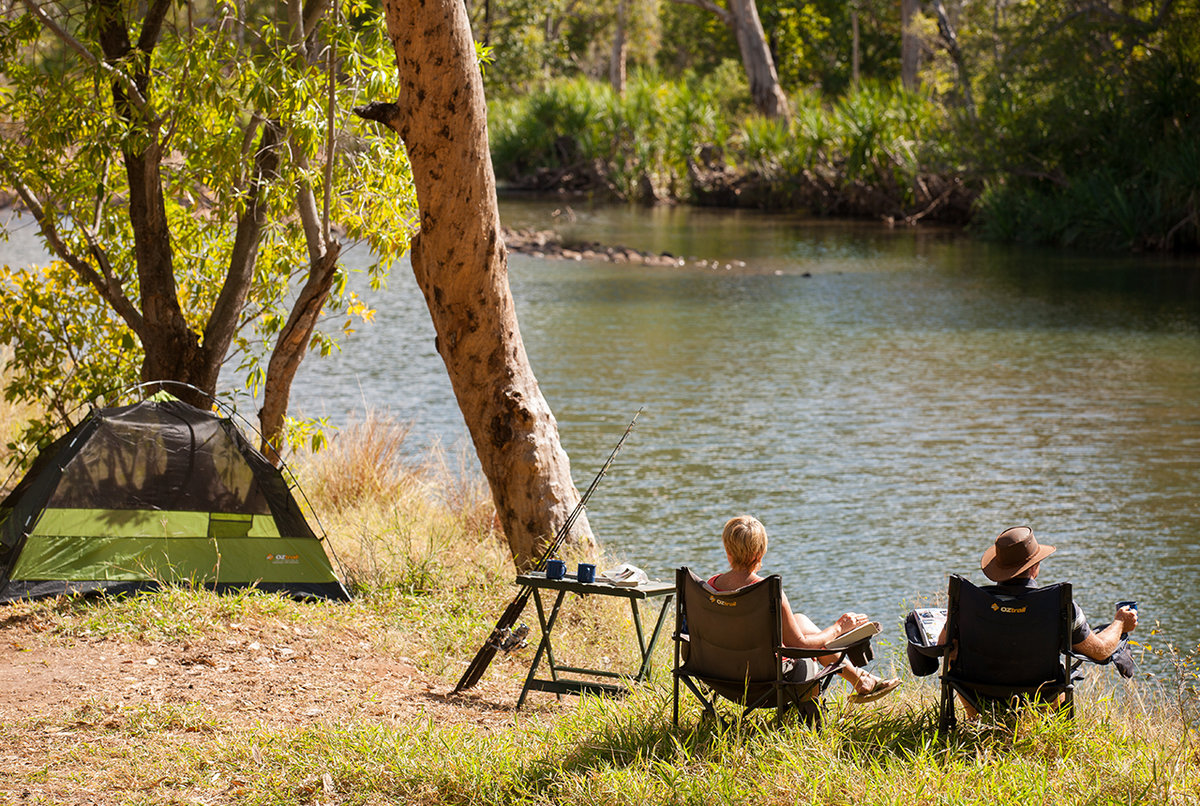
[0, 616, 537, 806]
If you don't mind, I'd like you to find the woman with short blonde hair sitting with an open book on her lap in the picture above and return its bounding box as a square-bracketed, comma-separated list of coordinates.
[706, 515, 900, 703]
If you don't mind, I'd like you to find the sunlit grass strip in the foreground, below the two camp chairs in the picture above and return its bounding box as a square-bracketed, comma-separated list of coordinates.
[7, 685, 1200, 806]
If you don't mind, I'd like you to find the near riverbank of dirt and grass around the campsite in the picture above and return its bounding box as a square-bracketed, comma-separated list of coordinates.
[0, 420, 1200, 805]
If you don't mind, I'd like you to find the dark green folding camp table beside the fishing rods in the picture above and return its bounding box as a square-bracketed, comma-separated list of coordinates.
[516, 571, 674, 709]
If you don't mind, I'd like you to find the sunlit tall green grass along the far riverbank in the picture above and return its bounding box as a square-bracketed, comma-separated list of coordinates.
[491, 74, 970, 217]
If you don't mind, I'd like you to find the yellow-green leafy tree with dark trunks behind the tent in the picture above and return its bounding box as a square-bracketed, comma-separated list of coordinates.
[0, 0, 415, 453]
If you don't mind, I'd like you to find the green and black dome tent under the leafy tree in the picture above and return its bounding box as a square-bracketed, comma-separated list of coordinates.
[0, 398, 349, 602]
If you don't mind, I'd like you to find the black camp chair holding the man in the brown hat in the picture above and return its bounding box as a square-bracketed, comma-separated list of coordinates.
[938, 575, 1082, 734]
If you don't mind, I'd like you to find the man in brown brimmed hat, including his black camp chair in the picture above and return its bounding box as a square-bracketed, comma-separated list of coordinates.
[938, 527, 1138, 727]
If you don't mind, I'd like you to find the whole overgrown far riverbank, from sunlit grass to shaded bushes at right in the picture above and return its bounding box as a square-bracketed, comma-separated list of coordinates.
[488, 76, 1200, 253]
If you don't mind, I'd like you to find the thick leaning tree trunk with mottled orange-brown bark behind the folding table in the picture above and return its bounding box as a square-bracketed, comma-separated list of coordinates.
[358, 0, 594, 567]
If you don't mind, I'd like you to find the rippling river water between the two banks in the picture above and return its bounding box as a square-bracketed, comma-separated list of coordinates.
[2, 200, 1200, 666]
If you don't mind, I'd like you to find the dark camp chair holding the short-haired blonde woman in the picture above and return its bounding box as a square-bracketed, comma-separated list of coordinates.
[672, 567, 871, 726]
